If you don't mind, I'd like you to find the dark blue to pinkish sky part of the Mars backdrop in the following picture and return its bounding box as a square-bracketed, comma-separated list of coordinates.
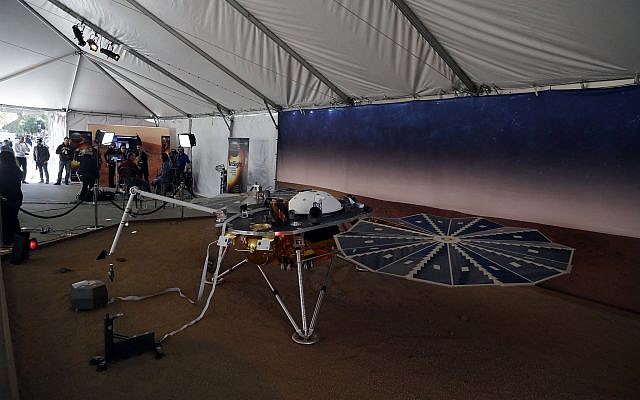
[278, 87, 640, 237]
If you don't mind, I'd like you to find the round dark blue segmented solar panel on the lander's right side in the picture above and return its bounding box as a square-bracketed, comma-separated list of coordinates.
[335, 214, 573, 286]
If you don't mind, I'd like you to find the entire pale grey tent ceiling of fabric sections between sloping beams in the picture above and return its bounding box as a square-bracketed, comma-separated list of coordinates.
[0, 0, 640, 118]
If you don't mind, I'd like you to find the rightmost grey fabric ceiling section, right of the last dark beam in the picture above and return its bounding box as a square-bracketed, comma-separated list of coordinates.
[406, 0, 640, 88]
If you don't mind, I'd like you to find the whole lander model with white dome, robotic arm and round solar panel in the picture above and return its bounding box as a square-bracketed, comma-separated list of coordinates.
[101, 187, 573, 344]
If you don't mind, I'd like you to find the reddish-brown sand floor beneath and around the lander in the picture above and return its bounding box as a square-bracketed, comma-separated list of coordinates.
[3, 193, 640, 400]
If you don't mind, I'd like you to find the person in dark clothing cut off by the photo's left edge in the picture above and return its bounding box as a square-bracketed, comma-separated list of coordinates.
[0, 151, 22, 246]
